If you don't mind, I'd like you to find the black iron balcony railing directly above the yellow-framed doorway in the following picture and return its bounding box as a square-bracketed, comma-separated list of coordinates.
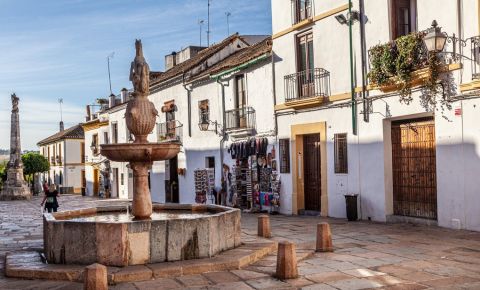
[285, 68, 330, 102]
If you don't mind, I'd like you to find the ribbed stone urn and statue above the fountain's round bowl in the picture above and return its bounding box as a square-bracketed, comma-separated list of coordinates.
[125, 39, 158, 143]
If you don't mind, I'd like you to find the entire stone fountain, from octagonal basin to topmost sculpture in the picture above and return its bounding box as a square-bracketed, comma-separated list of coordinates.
[43, 40, 241, 266]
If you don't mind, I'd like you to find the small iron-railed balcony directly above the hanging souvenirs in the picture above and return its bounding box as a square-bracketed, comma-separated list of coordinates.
[225, 107, 256, 137]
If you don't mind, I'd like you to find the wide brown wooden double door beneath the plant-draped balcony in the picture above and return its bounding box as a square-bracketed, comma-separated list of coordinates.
[392, 118, 437, 219]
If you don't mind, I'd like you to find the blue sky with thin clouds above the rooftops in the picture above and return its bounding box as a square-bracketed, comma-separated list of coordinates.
[0, 0, 271, 149]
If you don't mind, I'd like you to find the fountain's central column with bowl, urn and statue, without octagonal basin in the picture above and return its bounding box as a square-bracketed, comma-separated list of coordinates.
[101, 40, 180, 219]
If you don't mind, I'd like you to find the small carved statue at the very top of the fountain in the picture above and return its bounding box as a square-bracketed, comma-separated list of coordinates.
[130, 39, 150, 95]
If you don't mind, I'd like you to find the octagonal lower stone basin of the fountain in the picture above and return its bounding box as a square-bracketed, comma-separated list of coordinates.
[43, 204, 241, 267]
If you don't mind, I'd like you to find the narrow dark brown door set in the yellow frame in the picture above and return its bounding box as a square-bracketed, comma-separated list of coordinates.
[303, 134, 321, 211]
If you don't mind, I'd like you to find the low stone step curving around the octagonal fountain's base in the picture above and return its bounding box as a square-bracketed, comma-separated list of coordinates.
[5, 239, 278, 285]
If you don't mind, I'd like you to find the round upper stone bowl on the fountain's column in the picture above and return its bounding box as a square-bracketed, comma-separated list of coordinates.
[101, 142, 180, 162]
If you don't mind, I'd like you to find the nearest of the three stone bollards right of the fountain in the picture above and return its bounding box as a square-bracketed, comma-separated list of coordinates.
[276, 242, 298, 280]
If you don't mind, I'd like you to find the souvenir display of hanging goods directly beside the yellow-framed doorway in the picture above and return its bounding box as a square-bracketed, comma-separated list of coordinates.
[228, 138, 280, 212]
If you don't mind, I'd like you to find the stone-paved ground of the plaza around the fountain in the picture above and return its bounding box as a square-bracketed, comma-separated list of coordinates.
[0, 196, 480, 290]
